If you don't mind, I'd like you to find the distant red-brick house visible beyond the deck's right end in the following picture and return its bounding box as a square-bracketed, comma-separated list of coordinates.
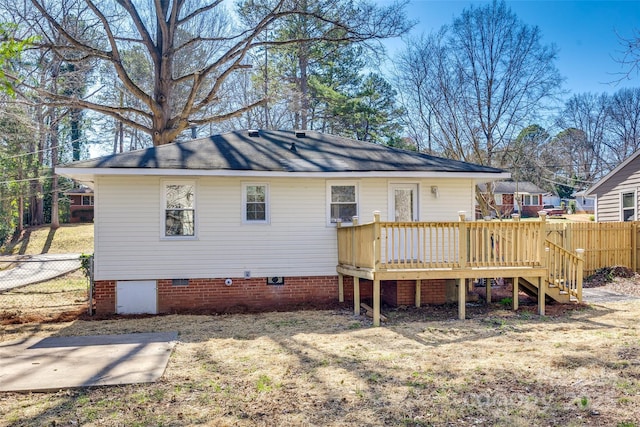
[478, 181, 547, 217]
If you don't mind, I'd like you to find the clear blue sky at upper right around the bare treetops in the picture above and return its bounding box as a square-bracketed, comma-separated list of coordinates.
[378, 0, 640, 94]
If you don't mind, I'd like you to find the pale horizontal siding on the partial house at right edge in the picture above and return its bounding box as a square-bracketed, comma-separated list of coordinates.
[595, 157, 640, 222]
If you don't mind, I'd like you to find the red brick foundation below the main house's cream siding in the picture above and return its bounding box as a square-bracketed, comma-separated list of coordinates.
[94, 276, 456, 314]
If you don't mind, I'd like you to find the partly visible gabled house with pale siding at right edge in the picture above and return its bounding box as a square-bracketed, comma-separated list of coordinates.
[584, 150, 640, 222]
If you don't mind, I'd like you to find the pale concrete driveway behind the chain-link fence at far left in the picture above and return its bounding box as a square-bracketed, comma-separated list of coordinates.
[0, 254, 80, 292]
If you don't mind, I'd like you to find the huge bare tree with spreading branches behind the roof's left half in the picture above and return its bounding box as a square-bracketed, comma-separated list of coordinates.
[10, 0, 404, 145]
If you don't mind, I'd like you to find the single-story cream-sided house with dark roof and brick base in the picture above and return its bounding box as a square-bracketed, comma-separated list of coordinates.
[57, 131, 509, 313]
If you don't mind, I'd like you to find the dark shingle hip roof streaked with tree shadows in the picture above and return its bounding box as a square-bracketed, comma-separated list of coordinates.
[64, 131, 503, 173]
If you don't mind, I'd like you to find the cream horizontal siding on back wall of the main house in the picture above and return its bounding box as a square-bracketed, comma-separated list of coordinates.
[95, 176, 475, 280]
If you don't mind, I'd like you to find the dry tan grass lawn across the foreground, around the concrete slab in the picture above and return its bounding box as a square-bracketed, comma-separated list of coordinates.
[0, 301, 640, 426]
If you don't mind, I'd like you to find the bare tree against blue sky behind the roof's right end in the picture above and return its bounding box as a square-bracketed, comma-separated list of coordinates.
[396, 1, 561, 165]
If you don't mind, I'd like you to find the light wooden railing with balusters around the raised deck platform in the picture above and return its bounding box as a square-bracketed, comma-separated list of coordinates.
[338, 214, 546, 270]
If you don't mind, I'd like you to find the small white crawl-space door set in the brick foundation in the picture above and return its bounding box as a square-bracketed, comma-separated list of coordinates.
[116, 280, 158, 314]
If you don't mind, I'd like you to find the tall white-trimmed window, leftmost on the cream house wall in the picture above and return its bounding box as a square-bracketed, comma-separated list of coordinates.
[162, 181, 196, 238]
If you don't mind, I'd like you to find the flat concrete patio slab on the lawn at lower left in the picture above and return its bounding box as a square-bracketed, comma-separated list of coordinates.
[0, 332, 178, 392]
